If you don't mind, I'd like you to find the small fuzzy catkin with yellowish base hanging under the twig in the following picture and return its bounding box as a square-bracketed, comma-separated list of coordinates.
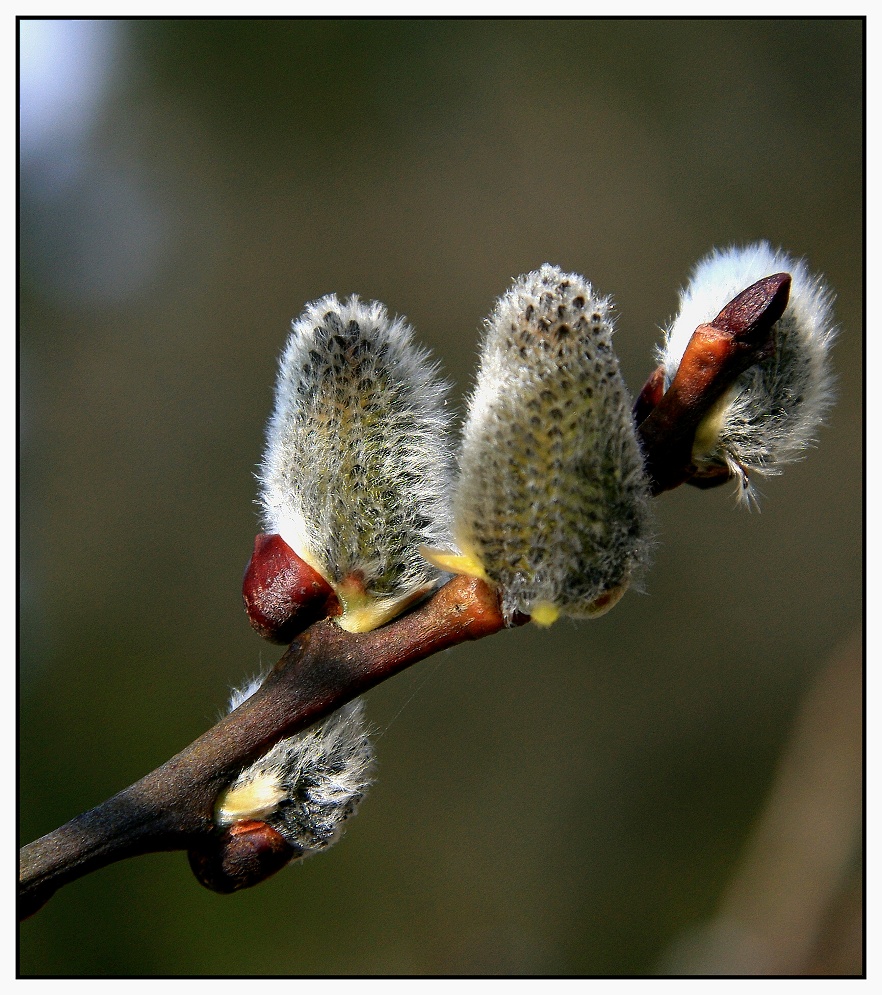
[215, 699, 374, 852]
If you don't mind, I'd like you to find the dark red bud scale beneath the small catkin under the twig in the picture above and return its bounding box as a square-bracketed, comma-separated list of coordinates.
[188, 819, 301, 895]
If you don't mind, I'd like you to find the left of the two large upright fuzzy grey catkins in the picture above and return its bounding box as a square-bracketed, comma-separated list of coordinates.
[259, 294, 451, 631]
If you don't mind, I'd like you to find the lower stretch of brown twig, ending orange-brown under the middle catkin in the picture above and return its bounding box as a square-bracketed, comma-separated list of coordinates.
[19, 577, 504, 917]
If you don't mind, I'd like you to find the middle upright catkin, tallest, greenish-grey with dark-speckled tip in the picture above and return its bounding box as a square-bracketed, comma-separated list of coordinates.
[455, 264, 649, 620]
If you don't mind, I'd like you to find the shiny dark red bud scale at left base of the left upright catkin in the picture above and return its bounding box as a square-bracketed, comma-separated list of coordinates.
[242, 534, 340, 643]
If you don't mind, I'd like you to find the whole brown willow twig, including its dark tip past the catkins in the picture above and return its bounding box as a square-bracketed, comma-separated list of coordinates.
[19, 274, 790, 918]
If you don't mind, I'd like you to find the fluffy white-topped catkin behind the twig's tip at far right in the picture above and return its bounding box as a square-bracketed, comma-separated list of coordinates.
[659, 242, 836, 504]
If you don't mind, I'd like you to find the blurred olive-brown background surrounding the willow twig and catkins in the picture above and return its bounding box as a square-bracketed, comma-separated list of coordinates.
[20, 19, 863, 975]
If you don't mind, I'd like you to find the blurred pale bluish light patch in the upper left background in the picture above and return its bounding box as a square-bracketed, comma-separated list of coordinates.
[19, 20, 170, 305]
